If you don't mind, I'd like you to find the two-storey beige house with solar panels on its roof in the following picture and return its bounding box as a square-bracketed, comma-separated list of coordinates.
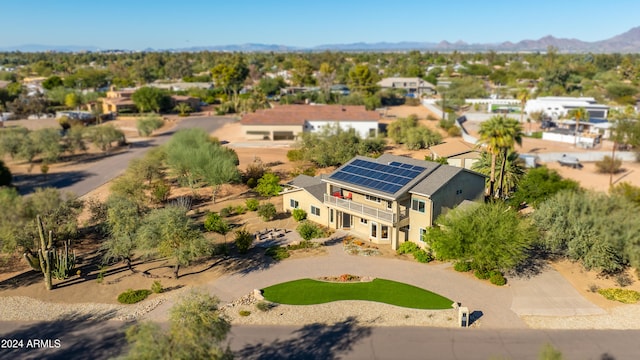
[282, 154, 485, 250]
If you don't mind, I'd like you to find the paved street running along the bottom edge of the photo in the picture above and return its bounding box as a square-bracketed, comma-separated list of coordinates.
[0, 319, 640, 360]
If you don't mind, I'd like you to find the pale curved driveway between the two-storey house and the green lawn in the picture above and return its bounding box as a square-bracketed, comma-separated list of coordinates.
[148, 233, 604, 328]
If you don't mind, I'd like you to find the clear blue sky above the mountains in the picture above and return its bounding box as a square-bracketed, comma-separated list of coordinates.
[0, 0, 640, 50]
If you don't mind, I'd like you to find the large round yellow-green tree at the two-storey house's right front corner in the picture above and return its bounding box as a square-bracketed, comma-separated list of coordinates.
[425, 202, 537, 272]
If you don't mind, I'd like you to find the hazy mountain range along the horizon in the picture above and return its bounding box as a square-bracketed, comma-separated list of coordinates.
[0, 26, 640, 53]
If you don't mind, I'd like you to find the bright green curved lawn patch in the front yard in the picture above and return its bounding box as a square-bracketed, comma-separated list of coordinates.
[264, 279, 453, 309]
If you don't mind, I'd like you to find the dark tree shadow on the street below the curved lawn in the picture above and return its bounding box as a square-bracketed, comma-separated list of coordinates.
[235, 317, 371, 360]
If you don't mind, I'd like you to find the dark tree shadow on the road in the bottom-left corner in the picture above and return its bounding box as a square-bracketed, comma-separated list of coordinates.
[0, 313, 128, 360]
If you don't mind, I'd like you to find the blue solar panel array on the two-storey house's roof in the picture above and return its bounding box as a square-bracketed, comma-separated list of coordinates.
[329, 159, 425, 194]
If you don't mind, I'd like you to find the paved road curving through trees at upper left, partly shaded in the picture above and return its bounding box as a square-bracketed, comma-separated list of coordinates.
[14, 116, 234, 196]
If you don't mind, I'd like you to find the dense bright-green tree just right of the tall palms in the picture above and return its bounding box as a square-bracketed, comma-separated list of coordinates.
[509, 166, 580, 208]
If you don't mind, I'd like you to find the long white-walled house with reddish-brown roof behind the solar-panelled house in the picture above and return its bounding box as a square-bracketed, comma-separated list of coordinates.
[240, 105, 380, 140]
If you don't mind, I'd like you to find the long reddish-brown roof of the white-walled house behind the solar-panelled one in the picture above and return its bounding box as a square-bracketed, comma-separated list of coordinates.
[240, 105, 380, 125]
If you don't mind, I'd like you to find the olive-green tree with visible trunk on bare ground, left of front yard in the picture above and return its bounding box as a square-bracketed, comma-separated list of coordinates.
[136, 206, 211, 279]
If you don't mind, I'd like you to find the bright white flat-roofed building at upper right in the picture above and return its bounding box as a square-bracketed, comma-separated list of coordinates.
[524, 96, 609, 120]
